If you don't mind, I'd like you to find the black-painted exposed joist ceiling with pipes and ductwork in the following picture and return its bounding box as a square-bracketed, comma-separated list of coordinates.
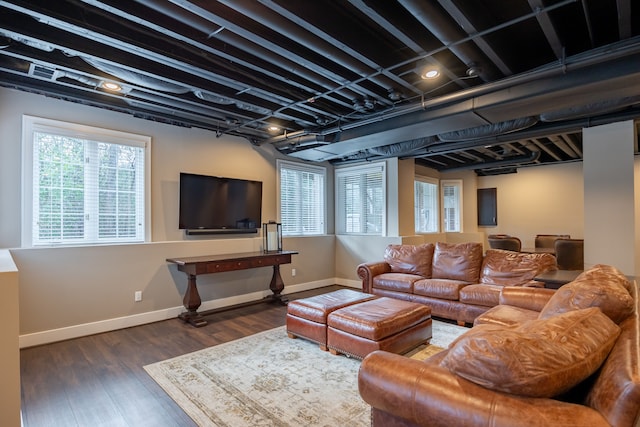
[0, 0, 640, 174]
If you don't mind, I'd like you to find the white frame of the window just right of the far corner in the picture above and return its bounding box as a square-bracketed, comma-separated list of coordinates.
[334, 162, 388, 236]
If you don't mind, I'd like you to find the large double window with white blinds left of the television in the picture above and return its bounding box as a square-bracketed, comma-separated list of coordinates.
[23, 116, 151, 246]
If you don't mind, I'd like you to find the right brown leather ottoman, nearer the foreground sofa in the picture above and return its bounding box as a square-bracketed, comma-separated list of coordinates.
[327, 297, 432, 359]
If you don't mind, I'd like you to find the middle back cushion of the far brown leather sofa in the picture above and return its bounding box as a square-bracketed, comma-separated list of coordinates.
[432, 242, 482, 283]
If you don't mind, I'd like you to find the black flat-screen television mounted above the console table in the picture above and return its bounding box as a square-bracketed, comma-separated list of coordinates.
[179, 172, 262, 234]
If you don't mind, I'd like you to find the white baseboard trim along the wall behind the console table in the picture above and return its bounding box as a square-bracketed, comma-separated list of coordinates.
[19, 278, 360, 348]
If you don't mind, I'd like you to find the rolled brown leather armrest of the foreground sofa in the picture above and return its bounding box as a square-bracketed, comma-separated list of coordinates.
[358, 351, 609, 427]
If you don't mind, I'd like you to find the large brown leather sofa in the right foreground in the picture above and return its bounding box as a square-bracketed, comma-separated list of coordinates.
[358, 265, 640, 427]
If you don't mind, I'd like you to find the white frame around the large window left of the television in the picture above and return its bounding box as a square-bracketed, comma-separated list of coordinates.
[21, 115, 151, 247]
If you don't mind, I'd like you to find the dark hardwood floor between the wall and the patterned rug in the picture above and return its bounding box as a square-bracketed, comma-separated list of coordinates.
[20, 286, 348, 427]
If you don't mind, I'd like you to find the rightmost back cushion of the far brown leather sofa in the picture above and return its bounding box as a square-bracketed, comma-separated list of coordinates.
[480, 249, 556, 286]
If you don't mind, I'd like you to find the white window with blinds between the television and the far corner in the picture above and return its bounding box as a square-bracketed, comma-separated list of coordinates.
[276, 160, 326, 236]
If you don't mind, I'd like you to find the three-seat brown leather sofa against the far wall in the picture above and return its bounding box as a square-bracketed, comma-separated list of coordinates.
[357, 242, 556, 324]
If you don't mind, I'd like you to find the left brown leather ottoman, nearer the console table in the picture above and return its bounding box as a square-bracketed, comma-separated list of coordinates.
[287, 289, 377, 351]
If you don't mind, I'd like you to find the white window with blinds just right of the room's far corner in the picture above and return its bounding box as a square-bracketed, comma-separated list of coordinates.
[336, 163, 386, 236]
